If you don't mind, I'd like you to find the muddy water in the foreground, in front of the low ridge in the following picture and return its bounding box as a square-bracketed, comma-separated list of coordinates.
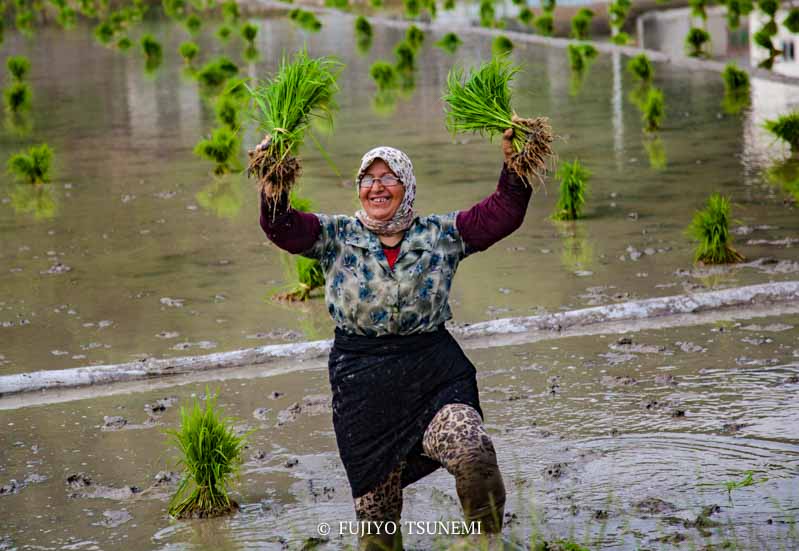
[0, 315, 799, 550]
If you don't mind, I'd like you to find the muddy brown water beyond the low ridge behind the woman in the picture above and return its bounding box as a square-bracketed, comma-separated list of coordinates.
[0, 17, 799, 374]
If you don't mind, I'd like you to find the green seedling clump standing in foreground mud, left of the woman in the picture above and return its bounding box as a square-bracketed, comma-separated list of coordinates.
[166, 390, 246, 518]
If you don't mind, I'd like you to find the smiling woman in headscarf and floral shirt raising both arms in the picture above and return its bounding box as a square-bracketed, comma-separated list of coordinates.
[261, 134, 531, 549]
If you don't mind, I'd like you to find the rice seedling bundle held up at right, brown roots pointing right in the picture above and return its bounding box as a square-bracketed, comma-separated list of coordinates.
[442, 57, 553, 187]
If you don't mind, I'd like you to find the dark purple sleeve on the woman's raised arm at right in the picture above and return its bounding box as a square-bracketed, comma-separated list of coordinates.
[455, 164, 533, 251]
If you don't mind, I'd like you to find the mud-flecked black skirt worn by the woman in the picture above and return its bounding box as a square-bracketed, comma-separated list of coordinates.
[328, 325, 483, 497]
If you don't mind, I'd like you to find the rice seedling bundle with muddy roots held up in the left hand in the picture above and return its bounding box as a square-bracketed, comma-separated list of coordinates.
[247, 51, 342, 202]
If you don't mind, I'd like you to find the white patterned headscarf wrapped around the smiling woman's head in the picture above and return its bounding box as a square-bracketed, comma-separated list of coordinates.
[355, 146, 416, 235]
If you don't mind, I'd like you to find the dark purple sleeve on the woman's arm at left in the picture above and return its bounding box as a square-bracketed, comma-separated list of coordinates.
[261, 195, 321, 254]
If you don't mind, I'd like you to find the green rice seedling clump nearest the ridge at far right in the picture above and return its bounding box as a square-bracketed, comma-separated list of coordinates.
[686, 193, 744, 264]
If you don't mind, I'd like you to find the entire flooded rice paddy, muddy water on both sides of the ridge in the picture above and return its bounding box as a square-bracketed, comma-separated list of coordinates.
[0, 9, 799, 550]
